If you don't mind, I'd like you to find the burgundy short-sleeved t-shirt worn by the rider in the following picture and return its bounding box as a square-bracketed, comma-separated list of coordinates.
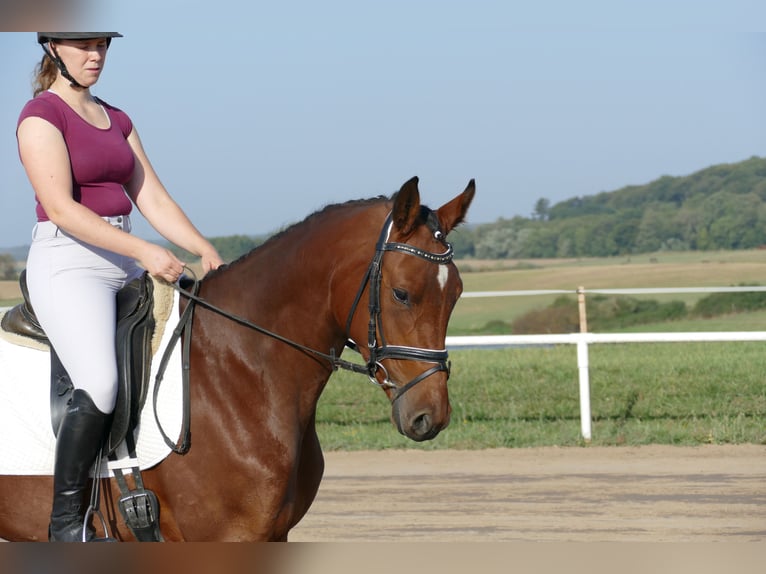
[17, 91, 135, 221]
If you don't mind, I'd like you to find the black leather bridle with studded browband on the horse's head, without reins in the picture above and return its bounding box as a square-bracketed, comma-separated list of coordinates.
[346, 212, 453, 403]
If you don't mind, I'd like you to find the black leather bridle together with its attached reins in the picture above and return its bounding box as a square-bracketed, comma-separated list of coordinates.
[154, 213, 454, 454]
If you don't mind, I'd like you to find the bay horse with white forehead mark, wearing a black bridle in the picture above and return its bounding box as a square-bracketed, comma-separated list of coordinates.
[0, 177, 475, 541]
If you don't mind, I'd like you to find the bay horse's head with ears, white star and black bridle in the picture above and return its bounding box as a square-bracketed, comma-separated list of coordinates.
[356, 177, 475, 441]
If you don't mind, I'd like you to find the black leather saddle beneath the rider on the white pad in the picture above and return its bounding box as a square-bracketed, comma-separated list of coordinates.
[1, 269, 155, 454]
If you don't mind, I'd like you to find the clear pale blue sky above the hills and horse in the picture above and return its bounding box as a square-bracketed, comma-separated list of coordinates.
[0, 0, 766, 247]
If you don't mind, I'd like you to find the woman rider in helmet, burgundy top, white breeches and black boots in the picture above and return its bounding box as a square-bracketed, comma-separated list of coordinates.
[16, 32, 222, 541]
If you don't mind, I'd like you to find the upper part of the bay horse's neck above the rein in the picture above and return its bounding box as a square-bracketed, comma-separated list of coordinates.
[203, 202, 389, 360]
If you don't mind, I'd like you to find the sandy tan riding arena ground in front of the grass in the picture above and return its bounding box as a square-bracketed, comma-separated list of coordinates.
[290, 445, 766, 542]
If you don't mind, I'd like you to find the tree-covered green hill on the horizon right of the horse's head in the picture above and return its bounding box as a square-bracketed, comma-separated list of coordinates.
[450, 157, 766, 259]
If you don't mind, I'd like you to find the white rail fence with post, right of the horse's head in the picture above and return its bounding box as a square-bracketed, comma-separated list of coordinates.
[447, 287, 766, 442]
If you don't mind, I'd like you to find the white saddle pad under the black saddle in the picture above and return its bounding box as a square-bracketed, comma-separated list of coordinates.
[0, 286, 182, 476]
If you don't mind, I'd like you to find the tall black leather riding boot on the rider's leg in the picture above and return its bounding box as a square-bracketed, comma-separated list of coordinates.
[48, 389, 111, 542]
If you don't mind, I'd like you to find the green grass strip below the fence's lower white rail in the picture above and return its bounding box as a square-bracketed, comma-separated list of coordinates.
[317, 343, 766, 450]
